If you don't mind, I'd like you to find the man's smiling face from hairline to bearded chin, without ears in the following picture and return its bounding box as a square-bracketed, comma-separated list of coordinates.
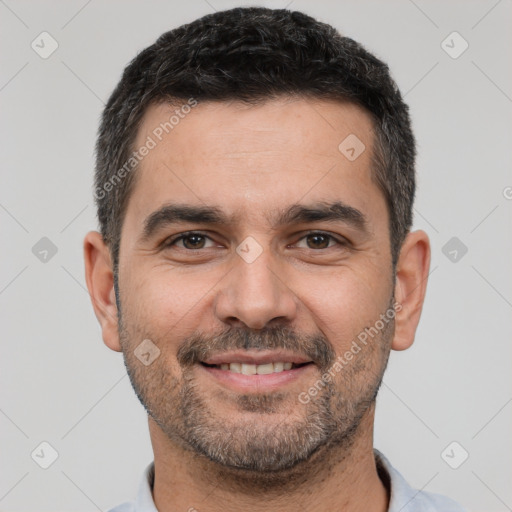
[118, 100, 394, 471]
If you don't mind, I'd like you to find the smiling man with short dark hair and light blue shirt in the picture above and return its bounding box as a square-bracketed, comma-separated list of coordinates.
[84, 8, 468, 512]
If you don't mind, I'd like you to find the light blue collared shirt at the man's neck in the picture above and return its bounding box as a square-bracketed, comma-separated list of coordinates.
[108, 449, 467, 512]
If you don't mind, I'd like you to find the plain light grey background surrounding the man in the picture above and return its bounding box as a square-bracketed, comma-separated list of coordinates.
[0, 0, 512, 512]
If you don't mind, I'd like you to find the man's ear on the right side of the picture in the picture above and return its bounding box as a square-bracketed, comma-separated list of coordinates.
[391, 230, 430, 350]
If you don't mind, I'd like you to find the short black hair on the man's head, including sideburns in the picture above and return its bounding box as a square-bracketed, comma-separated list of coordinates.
[94, 7, 416, 272]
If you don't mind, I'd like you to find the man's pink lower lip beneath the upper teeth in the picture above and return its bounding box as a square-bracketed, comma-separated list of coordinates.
[198, 364, 315, 393]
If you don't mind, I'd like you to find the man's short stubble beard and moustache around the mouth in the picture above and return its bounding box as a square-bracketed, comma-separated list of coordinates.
[119, 298, 394, 489]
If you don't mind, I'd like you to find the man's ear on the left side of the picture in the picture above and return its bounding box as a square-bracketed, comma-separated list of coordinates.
[84, 231, 121, 352]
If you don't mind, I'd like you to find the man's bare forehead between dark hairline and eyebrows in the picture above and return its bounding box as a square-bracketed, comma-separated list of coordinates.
[126, 99, 384, 235]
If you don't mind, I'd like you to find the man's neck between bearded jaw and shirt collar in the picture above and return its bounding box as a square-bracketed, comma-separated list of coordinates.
[149, 403, 389, 512]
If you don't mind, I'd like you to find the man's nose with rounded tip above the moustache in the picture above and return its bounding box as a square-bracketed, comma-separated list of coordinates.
[215, 248, 298, 329]
